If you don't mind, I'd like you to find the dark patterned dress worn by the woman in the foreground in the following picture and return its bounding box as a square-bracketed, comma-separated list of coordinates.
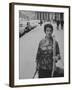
[36, 37, 60, 78]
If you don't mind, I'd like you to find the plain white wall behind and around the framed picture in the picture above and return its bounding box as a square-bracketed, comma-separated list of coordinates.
[0, 0, 72, 90]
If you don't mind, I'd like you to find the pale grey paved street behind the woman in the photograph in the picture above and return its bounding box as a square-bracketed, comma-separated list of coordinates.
[19, 23, 64, 79]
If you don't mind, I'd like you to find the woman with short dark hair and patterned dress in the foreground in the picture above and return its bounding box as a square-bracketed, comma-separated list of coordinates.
[36, 24, 60, 78]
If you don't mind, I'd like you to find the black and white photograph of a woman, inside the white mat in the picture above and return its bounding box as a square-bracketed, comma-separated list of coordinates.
[19, 10, 64, 79]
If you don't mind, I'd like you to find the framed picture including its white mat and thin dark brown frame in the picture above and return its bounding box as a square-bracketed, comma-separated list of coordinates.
[10, 3, 70, 86]
